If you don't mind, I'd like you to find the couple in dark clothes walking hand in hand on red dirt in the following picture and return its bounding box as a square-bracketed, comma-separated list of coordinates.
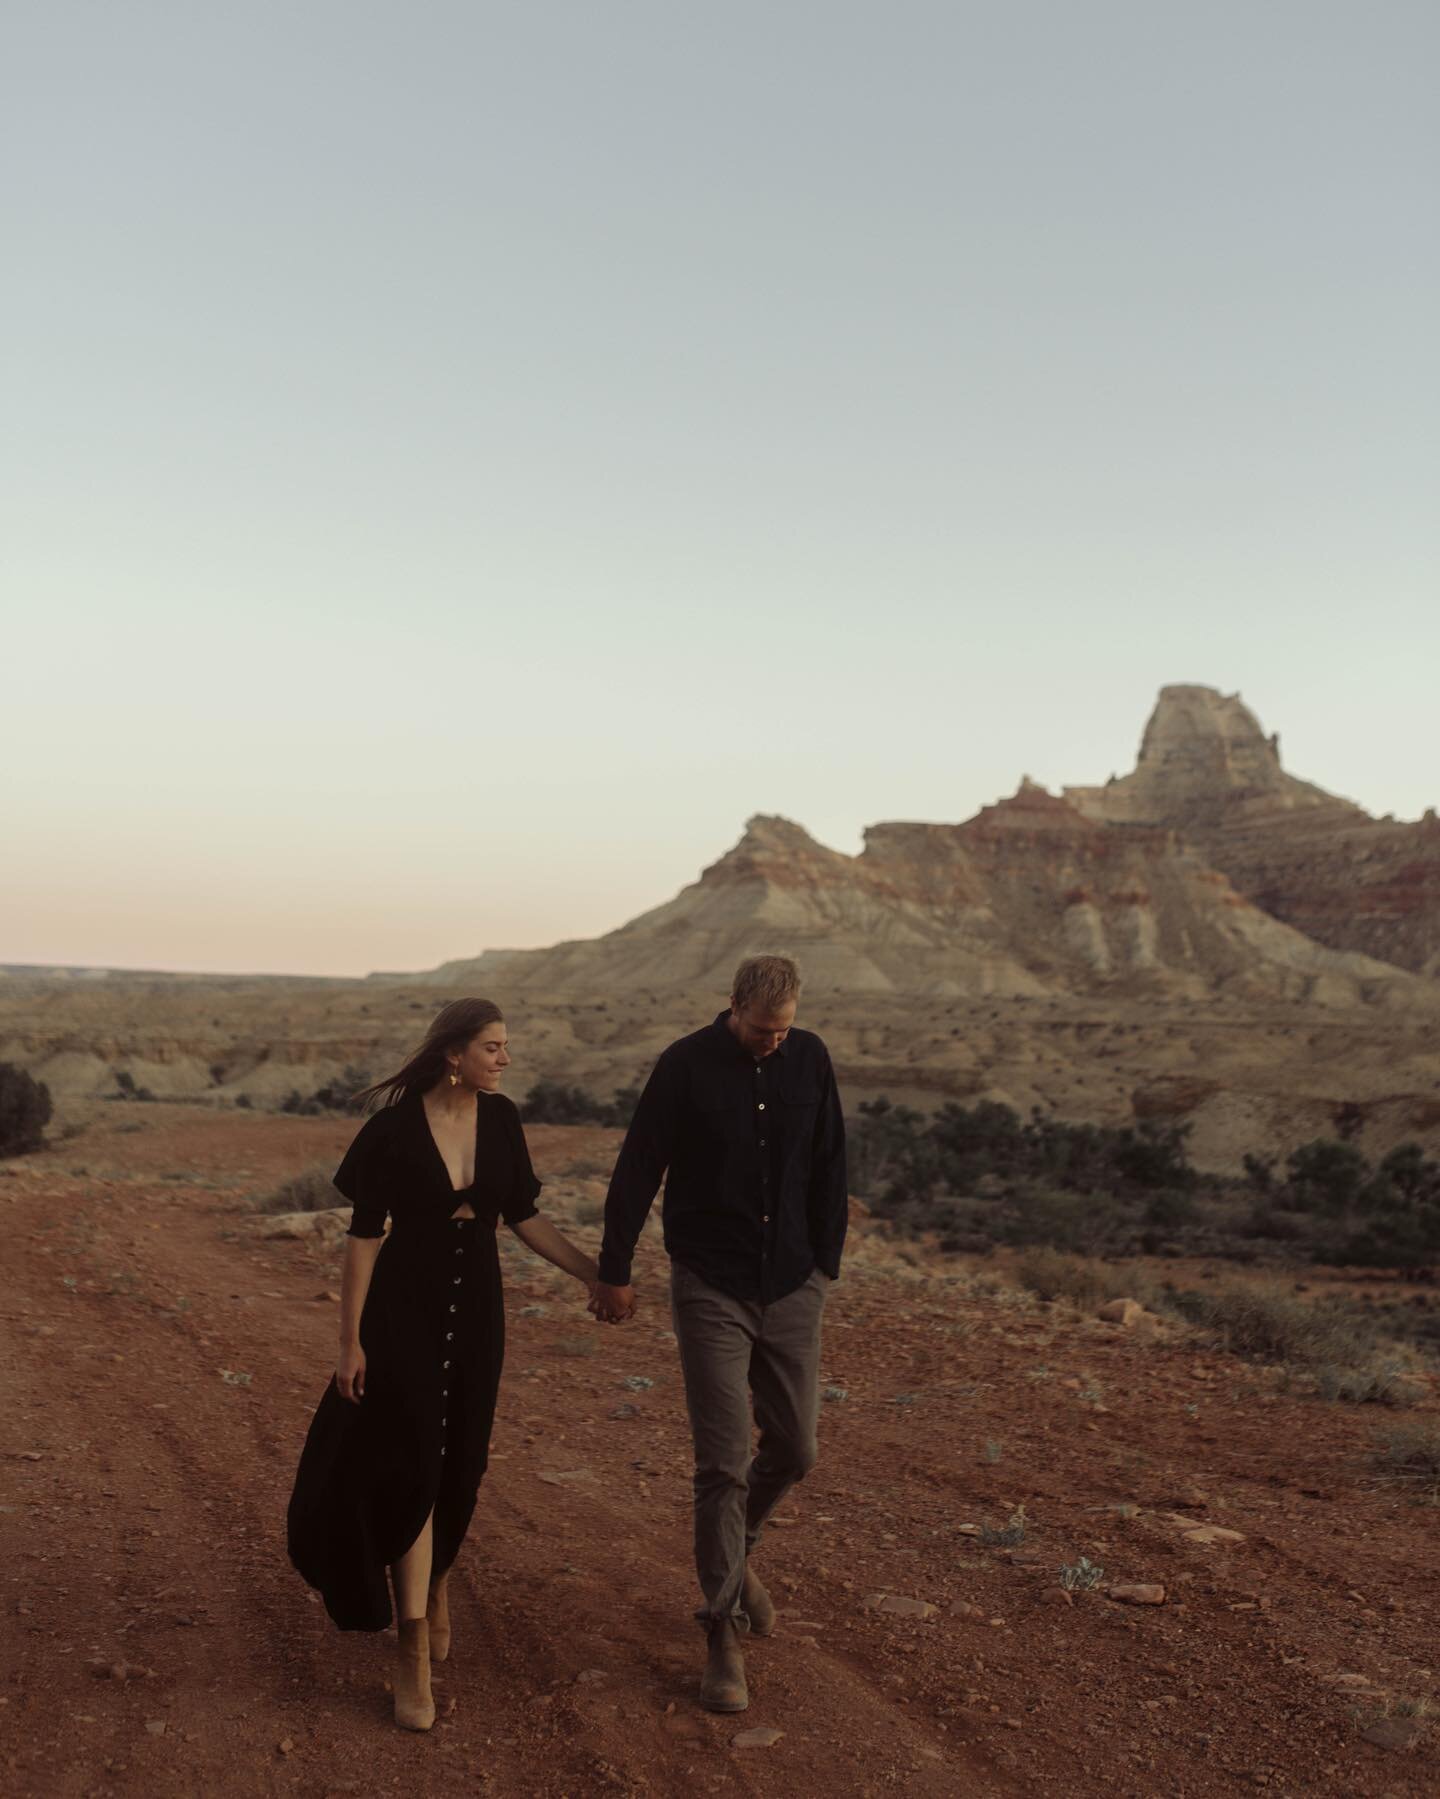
[288, 955, 848, 1731]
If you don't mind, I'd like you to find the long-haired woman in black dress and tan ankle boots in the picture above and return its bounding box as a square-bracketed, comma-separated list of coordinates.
[288, 1000, 598, 1731]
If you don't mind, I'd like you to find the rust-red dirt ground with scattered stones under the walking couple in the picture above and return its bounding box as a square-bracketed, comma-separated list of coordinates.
[0, 1105, 1440, 1799]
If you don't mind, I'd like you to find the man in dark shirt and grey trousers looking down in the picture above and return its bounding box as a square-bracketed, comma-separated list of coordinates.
[590, 955, 848, 1711]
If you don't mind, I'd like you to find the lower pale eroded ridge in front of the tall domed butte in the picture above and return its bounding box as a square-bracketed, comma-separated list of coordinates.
[430, 781, 1426, 1006]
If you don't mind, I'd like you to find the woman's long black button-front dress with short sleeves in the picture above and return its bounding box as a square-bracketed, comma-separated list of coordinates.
[286, 1094, 540, 1630]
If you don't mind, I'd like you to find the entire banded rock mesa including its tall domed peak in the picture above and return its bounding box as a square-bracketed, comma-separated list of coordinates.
[410, 685, 1440, 1007]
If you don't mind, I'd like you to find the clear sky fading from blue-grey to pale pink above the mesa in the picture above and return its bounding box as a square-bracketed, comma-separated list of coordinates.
[0, 0, 1440, 973]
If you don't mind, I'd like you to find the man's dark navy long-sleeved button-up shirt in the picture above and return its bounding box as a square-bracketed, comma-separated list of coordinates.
[599, 1011, 850, 1304]
